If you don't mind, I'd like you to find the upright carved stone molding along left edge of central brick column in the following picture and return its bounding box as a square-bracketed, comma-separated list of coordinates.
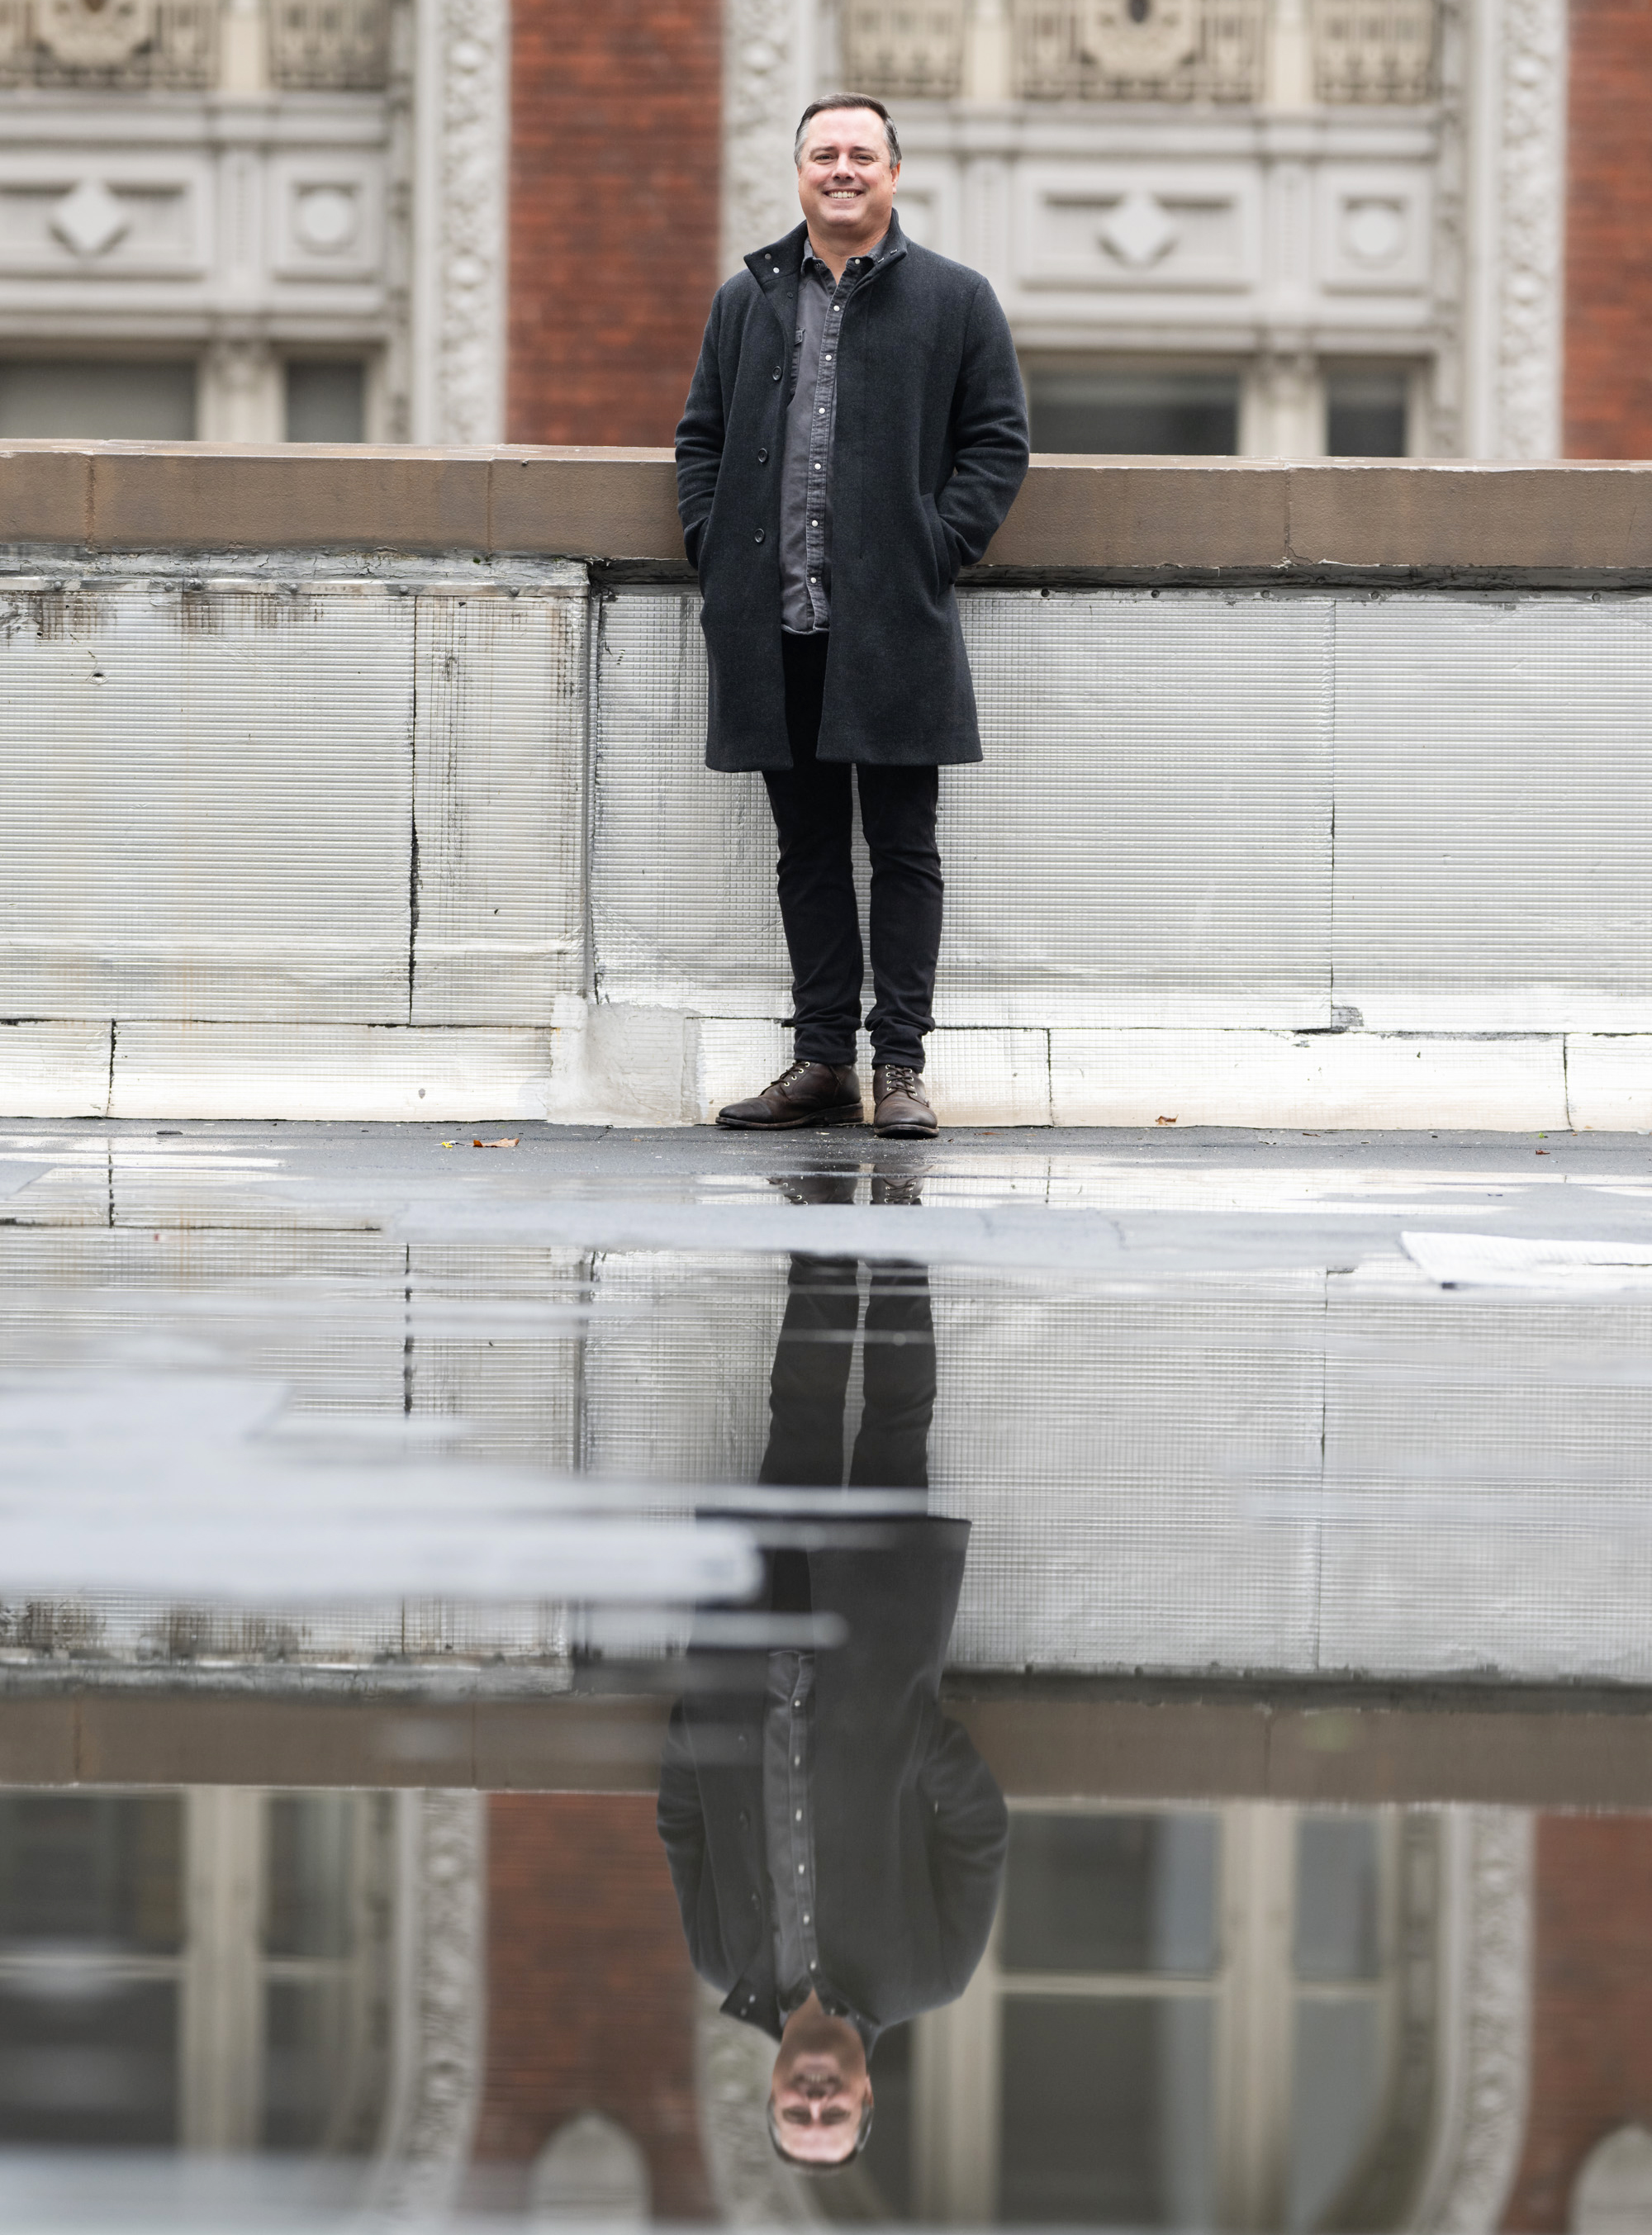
[414, 0, 510, 443]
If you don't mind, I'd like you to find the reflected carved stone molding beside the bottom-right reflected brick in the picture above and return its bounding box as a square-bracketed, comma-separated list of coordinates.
[1412, 1808, 1534, 2235]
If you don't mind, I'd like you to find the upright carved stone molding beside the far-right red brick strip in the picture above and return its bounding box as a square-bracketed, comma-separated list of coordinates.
[1493, 0, 1567, 458]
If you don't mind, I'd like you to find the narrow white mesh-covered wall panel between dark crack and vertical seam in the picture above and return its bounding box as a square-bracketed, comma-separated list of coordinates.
[411, 590, 590, 1023]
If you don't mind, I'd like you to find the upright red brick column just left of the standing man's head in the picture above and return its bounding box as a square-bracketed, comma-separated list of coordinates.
[506, 0, 722, 443]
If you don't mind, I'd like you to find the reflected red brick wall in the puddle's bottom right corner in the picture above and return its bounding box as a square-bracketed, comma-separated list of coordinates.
[1502, 1824, 1652, 2235]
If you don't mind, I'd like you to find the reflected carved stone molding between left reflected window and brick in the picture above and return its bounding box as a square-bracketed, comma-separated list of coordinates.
[364, 1792, 487, 2228]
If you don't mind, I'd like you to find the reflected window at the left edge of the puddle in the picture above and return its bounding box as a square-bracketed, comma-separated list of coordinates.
[0, 1788, 389, 2152]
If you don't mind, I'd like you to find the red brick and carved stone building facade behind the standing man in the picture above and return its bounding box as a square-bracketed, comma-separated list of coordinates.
[0, 0, 1652, 456]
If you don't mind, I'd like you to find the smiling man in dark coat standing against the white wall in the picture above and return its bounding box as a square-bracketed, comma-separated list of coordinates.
[677, 94, 1028, 1136]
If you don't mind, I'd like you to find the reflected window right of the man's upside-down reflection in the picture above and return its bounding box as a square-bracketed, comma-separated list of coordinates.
[912, 1806, 1435, 2231]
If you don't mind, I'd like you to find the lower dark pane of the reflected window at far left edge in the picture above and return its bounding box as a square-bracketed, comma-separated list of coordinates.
[0, 1993, 179, 2150]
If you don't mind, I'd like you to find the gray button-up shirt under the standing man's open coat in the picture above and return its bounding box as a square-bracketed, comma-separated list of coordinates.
[781, 232, 890, 637]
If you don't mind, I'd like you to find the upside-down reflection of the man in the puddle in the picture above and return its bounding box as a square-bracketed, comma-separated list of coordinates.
[659, 1182, 1006, 2168]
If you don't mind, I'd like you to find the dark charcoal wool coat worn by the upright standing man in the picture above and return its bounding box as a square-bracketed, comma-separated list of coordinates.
[677, 219, 1028, 769]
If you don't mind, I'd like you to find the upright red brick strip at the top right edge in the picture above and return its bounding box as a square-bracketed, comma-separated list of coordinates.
[1564, 0, 1652, 458]
